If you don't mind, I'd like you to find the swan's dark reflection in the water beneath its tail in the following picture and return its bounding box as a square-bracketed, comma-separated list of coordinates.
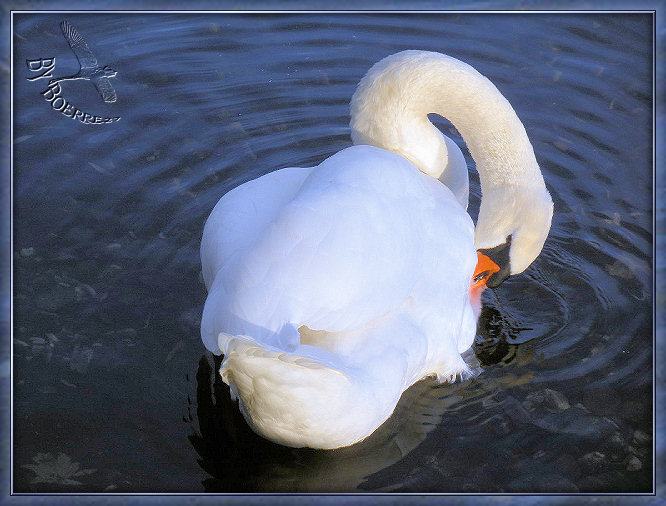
[190, 355, 474, 492]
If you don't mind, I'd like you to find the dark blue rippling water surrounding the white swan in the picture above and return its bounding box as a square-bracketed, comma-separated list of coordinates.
[13, 14, 653, 492]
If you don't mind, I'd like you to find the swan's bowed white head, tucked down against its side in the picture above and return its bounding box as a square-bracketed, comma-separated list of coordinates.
[475, 180, 553, 288]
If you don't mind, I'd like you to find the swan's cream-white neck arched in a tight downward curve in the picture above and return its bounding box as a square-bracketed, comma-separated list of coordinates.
[351, 51, 545, 193]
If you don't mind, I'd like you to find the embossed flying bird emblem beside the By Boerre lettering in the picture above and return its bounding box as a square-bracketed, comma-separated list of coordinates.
[49, 21, 118, 103]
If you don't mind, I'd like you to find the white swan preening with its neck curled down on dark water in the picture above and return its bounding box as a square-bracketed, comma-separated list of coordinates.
[201, 51, 553, 448]
